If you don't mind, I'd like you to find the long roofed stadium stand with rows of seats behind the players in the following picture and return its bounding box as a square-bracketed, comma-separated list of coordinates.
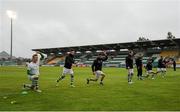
[30, 38, 180, 67]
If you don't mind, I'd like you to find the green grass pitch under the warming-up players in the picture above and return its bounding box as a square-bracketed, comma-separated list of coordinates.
[0, 66, 180, 111]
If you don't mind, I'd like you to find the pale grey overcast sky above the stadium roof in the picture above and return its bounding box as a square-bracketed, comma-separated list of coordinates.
[0, 0, 180, 57]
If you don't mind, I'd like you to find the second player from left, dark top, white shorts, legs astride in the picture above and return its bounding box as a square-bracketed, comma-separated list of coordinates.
[56, 50, 75, 87]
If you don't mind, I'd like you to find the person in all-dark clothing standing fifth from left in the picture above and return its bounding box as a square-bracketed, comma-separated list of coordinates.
[136, 54, 143, 80]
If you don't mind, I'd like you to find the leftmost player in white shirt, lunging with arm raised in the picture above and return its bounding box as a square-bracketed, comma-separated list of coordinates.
[24, 54, 41, 92]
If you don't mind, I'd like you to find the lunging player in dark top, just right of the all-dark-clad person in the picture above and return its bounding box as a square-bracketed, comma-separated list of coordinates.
[146, 58, 156, 79]
